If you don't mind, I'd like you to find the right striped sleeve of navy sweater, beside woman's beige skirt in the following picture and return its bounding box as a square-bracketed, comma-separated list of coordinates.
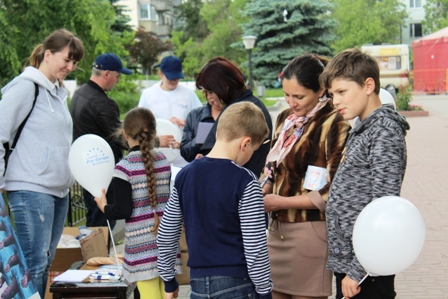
[238, 180, 273, 298]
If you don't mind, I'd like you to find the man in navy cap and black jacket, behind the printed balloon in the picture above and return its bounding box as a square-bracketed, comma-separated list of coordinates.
[70, 53, 132, 236]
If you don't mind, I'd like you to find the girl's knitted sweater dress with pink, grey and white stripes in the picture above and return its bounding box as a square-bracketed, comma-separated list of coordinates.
[114, 150, 181, 283]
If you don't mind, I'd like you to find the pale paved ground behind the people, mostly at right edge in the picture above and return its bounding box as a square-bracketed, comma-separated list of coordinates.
[118, 96, 448, 299]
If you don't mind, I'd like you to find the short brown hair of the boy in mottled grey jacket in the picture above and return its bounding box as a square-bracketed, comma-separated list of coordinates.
[319, 48, 380, 94]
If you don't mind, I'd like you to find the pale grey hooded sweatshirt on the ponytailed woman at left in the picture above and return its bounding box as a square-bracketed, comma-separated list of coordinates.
[0, 67, 74, 197]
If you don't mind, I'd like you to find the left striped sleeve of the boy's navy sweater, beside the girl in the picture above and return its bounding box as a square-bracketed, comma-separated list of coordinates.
[157, 188, 183, 293]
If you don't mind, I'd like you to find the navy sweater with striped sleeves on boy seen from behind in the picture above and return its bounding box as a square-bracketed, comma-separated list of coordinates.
[157, 157, 272, 298]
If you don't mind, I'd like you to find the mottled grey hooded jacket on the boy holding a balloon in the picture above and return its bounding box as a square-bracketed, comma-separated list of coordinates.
[326, 105, 409, 281]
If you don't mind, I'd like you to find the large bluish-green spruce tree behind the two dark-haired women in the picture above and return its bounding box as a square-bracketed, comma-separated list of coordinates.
[240, 0, 336, 86]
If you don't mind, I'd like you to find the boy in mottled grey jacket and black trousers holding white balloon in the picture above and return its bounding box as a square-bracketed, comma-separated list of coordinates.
[320, 49, 409, 299]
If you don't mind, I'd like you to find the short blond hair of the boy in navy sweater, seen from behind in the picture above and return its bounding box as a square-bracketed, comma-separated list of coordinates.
[216, 102, 269, 144]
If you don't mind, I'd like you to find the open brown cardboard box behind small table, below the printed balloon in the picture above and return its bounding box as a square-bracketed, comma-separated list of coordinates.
[45, 227, 109, 299]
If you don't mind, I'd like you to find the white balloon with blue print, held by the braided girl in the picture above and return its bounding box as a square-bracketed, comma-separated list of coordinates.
[68, 134, 115, 197]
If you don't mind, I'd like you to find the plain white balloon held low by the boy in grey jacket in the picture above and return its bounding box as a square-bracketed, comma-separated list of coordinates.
[353, 196, 425, 276]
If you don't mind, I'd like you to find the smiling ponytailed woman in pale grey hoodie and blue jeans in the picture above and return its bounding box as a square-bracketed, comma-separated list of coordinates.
[0, 29, 84, 298]
